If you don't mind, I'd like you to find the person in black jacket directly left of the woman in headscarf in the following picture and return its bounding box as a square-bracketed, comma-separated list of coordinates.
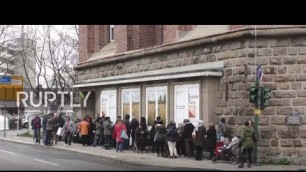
[182, 119, 194, 158]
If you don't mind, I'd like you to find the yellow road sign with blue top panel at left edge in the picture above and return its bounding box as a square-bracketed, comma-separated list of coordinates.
[0, 75, 23, 101]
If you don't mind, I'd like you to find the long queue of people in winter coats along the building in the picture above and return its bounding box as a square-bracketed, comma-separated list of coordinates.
[31, 113, 255, 168]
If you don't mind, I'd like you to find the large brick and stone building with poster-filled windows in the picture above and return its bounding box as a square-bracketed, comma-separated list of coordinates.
[74, 25, 306, 163]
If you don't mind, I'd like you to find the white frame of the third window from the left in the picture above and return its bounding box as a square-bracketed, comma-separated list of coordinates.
[146, 86, 168, 127]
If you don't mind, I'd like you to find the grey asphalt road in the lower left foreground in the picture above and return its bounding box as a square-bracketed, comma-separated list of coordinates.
[0, 140, 206, 171]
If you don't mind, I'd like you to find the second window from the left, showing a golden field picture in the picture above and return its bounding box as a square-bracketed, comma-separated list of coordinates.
[121, 88, 140, 121]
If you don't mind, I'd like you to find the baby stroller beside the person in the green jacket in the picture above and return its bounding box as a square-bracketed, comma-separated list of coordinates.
[212, 137, 240, 164]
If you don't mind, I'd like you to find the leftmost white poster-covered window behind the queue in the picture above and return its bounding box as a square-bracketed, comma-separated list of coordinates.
[100, 90, 117, 124]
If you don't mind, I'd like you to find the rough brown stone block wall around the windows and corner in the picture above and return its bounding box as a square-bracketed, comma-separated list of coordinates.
[77, 27, 306, 163]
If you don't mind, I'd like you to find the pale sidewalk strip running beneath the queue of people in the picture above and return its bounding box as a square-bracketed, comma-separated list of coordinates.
[0, 135, 306, 171]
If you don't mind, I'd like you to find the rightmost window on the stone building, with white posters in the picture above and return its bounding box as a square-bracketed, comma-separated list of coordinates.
[174, 84, 200, 124]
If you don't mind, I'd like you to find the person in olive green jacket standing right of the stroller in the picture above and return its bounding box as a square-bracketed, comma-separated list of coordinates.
[238, 121, 255, 168]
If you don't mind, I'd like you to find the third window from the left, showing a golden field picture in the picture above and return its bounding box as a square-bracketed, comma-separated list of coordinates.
[146, 86, 168, 126]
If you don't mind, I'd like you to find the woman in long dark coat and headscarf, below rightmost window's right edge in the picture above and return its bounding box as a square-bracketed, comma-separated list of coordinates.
[194, 120, 206, 161]
